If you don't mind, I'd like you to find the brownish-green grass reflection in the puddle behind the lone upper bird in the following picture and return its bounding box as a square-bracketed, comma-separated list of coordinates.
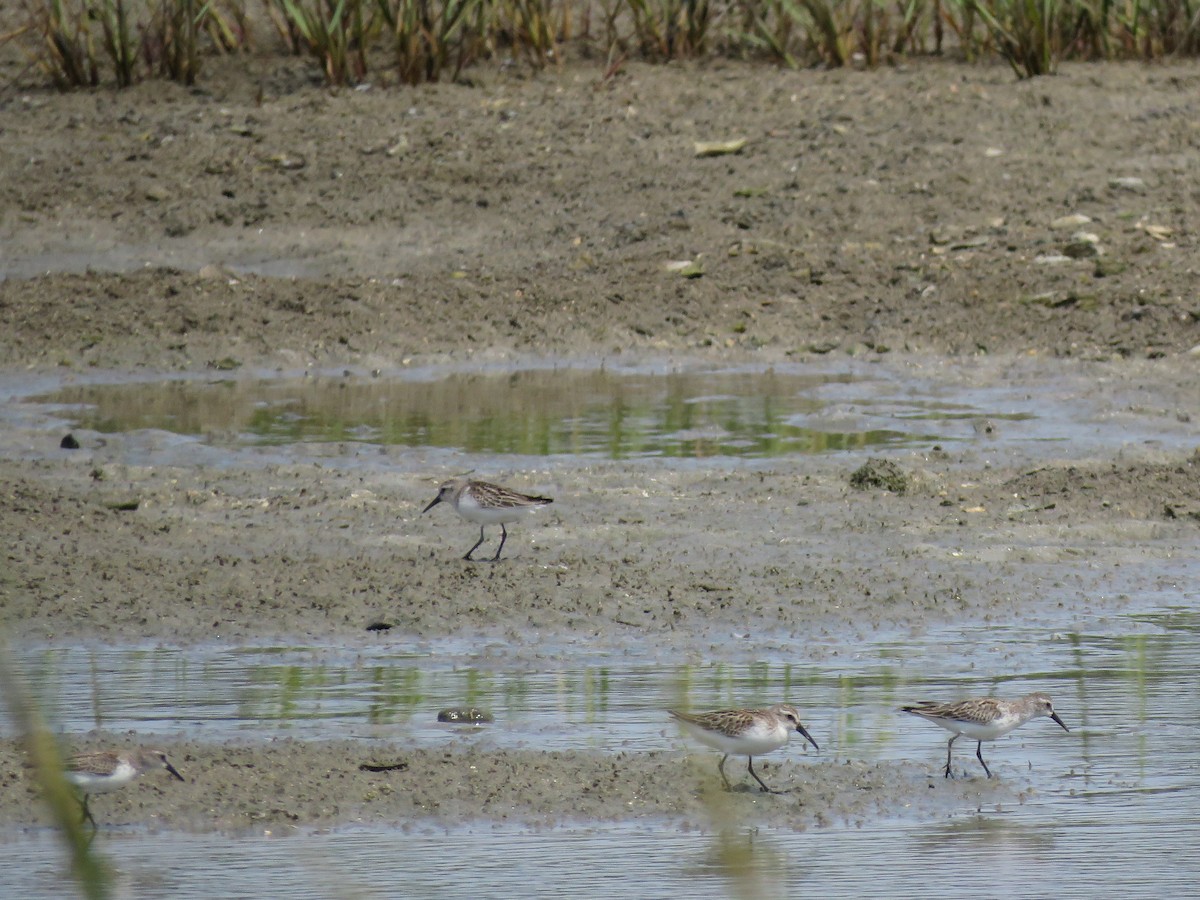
[30, 368, 984, 460]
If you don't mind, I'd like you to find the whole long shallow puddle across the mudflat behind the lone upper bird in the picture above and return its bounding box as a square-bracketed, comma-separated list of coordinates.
[0, 360, 1193, 462]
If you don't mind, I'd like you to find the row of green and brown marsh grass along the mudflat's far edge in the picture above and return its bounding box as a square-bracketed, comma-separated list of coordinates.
[7, 0, 1200, 89]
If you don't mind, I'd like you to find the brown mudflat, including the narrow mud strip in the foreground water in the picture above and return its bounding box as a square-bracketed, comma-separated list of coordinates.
[0, 47, 1200, 829]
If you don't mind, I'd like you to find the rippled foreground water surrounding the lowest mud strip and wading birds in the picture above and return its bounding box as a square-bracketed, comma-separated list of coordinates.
[0, 593, 1200, 898]
